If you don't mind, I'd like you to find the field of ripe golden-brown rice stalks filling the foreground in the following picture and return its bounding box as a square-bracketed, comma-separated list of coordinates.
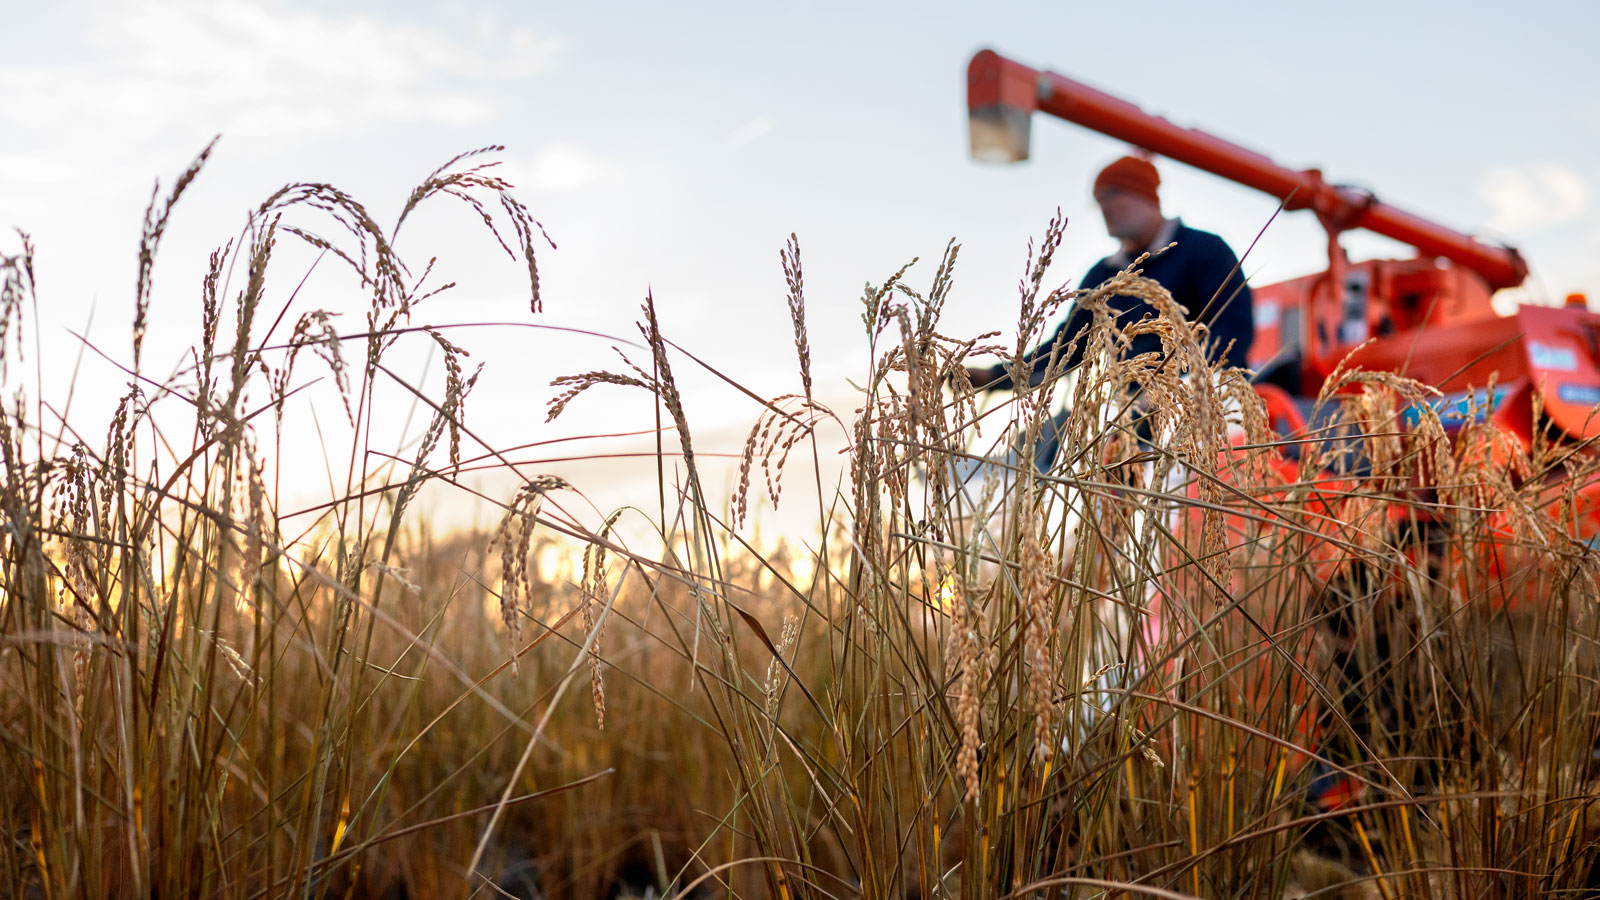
[0, 149, 1600, 900]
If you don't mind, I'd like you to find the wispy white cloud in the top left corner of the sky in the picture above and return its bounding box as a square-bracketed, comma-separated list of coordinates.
[0, 0, 560, 144]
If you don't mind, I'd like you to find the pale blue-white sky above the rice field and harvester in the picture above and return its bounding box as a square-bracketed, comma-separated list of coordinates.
[0, 0, 1600, 531]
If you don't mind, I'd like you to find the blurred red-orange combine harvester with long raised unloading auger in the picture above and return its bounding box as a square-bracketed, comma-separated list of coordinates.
[966, 50, 1600, 569]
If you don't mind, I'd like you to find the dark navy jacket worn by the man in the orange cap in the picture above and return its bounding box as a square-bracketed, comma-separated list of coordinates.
[987, 219, 1256, 391]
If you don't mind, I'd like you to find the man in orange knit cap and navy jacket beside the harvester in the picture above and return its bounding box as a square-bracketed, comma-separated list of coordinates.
[966, 157, 1256, 468]
